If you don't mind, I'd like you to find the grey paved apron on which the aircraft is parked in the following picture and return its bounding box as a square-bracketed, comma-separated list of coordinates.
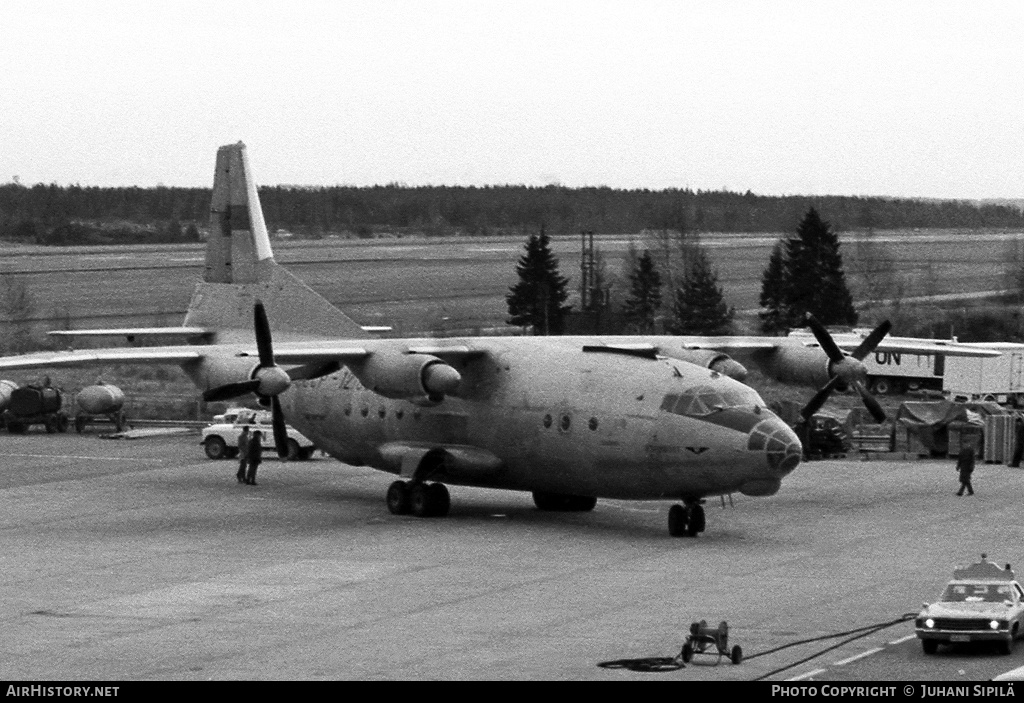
[0, 434, 1024, 680]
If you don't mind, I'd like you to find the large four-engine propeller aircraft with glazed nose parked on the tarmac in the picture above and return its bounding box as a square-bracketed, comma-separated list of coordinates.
[0, 142, 999, 536]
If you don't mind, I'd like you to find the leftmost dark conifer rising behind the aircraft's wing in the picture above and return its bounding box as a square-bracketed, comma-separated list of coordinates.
[505, 225, 571, 335]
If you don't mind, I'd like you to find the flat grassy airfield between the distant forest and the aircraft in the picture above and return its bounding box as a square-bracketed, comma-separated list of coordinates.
[0, 231, 1024, 418]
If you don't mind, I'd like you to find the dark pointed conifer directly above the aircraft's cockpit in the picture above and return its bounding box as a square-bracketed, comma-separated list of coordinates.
[668, 247, 736, 335]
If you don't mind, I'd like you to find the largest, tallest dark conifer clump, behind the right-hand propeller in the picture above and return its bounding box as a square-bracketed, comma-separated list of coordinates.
[761, 208, 857, 332]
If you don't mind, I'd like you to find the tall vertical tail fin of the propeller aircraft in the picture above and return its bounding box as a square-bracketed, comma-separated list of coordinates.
[184, 141, 369, 342]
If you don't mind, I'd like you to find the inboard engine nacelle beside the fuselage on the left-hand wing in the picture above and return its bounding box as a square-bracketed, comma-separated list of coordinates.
[347, 351, 462, 401]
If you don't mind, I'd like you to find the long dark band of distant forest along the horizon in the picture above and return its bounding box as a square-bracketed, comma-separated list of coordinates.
[0, 183, 1024, 244]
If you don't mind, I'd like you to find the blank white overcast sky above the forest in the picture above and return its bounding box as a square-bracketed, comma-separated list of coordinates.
[0, 0, 1024, 199]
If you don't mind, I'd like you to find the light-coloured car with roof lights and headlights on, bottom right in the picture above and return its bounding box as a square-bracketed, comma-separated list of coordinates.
[915, 555, 1024, 654]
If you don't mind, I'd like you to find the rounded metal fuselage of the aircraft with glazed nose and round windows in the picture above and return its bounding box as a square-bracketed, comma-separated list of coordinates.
[218, 337, 802, 499]
